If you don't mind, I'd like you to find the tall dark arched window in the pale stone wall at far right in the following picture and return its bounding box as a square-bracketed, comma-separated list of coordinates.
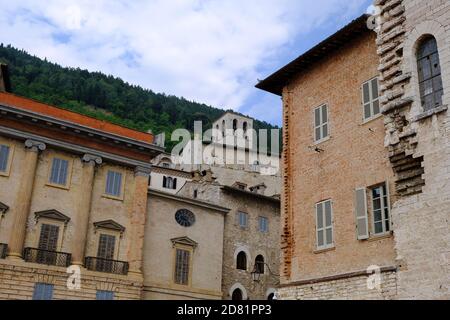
[417, 36, 444, 111]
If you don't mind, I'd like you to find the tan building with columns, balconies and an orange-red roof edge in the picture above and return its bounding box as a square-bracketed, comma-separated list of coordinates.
[0, 79, 162, 299]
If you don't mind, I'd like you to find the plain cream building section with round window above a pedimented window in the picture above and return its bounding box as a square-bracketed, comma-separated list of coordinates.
[143, 189, 229, 300]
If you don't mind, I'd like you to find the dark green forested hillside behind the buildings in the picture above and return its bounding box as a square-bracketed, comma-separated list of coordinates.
[0, 44, 276, 151]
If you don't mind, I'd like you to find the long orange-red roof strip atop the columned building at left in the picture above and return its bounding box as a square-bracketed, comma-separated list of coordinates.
[0, 92, 154, 143]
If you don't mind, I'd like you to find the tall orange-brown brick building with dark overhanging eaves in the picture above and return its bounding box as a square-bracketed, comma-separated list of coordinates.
[258, 15, 397, 299]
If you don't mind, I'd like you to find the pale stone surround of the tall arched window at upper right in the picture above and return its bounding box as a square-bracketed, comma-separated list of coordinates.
[402, 20, 450, 122]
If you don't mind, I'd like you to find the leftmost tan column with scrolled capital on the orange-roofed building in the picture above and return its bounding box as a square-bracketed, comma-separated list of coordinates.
[8, 140, 46, 259]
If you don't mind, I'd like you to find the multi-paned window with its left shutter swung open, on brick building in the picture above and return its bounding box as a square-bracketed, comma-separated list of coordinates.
[371, 183, 391, 235]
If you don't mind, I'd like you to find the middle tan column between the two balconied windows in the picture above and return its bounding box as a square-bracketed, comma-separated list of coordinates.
[72, 154, 103, 266]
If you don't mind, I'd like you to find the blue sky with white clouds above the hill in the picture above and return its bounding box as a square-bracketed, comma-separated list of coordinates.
[0, 0, 372, 124]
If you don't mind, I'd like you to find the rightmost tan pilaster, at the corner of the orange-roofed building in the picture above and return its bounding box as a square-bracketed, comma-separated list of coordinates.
[128, 167, 151, 276]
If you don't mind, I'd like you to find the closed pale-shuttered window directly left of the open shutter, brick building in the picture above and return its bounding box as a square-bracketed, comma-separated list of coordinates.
[316, 200, 334, 249]
